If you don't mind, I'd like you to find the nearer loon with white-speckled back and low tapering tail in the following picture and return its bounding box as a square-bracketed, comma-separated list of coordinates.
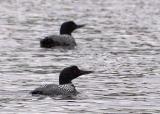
[31, 66, 93, 96]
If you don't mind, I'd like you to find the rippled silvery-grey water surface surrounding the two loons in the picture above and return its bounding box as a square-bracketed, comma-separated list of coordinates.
[0, 0, 160, 114]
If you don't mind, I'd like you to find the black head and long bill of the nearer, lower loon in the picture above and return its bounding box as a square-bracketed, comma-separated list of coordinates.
[59, 66, 93, 85]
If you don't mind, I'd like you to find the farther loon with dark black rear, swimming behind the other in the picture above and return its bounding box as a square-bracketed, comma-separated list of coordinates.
[40, 21, 85, 48]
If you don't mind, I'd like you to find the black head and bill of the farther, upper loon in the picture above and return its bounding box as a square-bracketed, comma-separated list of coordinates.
[60, 21, 84, 35]
